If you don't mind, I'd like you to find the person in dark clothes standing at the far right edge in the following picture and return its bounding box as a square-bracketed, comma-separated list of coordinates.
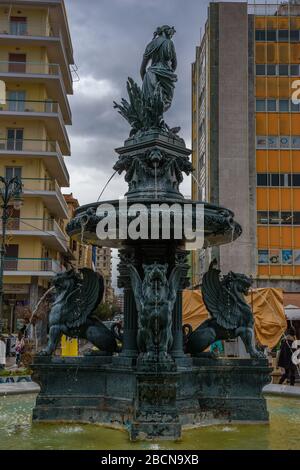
[278, 328, 296, 386]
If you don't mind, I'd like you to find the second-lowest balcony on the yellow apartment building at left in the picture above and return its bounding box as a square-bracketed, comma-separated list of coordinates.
[0, 218, 68, 253]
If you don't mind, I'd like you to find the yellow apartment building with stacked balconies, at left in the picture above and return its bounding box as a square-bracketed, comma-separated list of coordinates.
[0, 0, 74, 330]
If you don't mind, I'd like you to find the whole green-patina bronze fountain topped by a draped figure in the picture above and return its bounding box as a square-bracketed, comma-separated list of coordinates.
[32, 25, 270, 440]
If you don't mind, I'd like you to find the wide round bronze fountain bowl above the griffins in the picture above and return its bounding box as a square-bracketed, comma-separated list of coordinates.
[67, 198, 242, 249]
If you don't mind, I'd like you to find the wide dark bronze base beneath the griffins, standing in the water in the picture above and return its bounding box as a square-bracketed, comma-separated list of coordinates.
[32, 356, 271, 440]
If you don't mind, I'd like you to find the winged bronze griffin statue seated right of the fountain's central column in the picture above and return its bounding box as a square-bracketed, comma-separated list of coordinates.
[183, 261, 264, 358]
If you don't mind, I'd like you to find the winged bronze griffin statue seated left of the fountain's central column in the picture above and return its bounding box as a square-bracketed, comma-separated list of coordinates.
[40, 268, 120, 356]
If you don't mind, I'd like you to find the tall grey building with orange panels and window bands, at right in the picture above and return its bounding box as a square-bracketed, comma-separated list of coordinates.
[192, 1, 300, 292]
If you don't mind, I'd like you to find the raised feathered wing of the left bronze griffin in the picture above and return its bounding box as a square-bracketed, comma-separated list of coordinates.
[68, 268, 104, 328]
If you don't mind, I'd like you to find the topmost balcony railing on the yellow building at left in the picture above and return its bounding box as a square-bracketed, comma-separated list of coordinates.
[0, 18, 60, 37]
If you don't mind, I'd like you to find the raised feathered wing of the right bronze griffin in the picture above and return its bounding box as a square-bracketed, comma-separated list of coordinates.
[202, 266, 239, 329]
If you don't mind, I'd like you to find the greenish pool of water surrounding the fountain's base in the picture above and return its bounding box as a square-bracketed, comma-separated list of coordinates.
[0, 395, 300, 451]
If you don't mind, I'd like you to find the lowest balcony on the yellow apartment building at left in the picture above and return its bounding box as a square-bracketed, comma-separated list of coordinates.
[4, 257, 65, 279]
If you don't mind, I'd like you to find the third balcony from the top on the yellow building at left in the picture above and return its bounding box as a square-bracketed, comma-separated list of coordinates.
[0, 100, 71, 155]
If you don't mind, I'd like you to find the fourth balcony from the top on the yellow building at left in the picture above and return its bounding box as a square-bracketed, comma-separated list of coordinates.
[0, 139, 70, 187]
